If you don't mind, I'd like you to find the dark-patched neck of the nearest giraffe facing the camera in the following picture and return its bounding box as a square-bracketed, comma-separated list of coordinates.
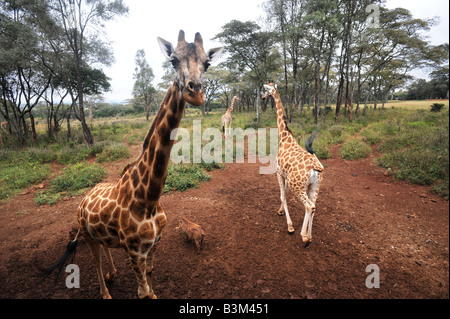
[123, 82, 186, 208]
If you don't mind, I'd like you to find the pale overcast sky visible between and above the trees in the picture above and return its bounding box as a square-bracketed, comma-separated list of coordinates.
[104, 0, 449, 103]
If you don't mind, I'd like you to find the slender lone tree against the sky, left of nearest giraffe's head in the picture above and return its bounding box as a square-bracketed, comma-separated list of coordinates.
[133, 49, 156, 121]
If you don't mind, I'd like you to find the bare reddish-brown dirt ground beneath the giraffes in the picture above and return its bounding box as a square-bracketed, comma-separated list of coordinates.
[0, 140, 449, 299]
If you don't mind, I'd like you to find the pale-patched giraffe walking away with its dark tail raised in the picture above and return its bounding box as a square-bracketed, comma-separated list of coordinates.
[262, 81, 324, 246]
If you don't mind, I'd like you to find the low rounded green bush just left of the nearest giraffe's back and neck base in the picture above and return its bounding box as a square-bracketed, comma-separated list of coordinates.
[51, 163, 106, 192]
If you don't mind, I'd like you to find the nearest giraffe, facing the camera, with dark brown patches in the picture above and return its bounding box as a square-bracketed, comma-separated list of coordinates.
[44, 31, 223, 299]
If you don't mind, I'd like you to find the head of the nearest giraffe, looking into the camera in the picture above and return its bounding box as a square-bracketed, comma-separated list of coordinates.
[158, 30, 223, 106]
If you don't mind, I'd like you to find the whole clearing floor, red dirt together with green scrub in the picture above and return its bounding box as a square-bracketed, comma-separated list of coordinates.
[0, 101, 449, 299]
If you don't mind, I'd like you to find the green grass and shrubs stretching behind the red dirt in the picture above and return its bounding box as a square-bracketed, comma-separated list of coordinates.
[0, 101, 449, 203]
